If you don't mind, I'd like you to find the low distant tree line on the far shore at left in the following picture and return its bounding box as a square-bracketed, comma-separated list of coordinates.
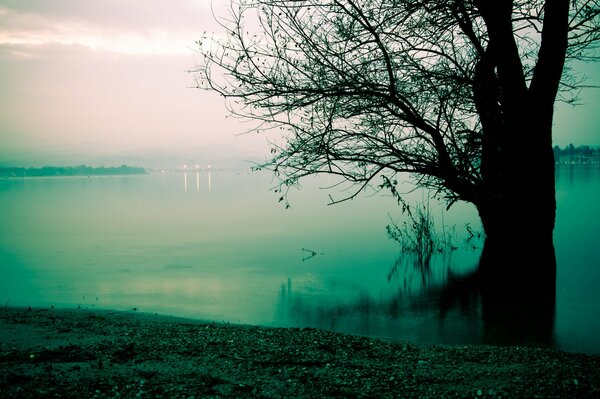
[0, 165, 146, 177]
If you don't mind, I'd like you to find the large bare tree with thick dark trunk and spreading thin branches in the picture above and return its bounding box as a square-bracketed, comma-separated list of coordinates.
[195, 0, 600, 285]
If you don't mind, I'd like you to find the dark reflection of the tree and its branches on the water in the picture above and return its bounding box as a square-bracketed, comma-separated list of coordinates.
[278, 248, 555, 347]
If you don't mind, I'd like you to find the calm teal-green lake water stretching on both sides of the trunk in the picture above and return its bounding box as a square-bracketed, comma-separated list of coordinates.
[0, 168, 600, 353]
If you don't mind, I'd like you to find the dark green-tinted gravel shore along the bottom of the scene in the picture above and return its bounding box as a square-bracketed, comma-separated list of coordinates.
[0, 308, 600, 398]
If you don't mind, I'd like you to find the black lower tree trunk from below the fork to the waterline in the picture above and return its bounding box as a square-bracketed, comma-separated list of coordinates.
[476, 115, 556, 295]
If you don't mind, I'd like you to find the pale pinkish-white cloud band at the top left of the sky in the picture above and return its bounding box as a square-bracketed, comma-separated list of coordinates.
[0, 0, 216, 55]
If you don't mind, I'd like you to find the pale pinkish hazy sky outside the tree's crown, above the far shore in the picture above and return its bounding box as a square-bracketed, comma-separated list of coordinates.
[0, 0, 600, 166]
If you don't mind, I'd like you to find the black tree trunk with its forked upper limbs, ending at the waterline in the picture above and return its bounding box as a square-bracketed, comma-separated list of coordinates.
[473, 0, 569, 293]
